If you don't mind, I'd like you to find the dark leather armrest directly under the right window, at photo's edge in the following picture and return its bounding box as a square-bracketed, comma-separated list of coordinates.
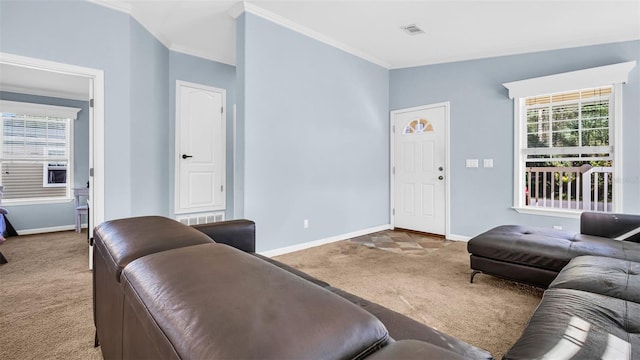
[580, 211, 640, 242]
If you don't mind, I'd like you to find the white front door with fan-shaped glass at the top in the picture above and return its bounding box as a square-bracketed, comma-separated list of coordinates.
[392, 103, 449, 235]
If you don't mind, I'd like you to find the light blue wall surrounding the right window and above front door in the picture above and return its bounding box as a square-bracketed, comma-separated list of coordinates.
[390, 41, 640, 236]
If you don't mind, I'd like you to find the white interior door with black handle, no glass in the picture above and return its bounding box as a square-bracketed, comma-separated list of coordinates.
[175, 81, 226, 214]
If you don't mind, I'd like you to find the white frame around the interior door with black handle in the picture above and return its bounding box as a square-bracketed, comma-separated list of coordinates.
[173, 80, 226, 215]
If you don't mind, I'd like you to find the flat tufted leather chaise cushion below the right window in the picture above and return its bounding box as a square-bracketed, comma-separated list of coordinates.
[467, 225, 640, 271]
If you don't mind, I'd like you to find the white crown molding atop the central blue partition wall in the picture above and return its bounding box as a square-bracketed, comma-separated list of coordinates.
[229, 1, 391, 69]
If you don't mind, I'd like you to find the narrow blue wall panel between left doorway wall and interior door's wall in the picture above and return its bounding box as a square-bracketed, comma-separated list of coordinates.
[130, 18, 173, 216]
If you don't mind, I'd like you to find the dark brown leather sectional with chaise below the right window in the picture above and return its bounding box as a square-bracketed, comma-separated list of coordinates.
[467, 212, 640, 359]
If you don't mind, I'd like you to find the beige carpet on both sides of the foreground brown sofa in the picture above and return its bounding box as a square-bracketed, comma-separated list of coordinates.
[0, 231, 542, 359]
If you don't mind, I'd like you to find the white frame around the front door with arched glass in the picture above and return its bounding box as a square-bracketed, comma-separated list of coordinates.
[389, 101, 451, 239]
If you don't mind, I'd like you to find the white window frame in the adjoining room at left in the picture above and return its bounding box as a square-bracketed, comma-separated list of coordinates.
[0, 100, 82, 206]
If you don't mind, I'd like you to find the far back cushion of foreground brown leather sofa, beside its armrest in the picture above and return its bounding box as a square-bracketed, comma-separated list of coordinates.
[94, 216, 213, 282]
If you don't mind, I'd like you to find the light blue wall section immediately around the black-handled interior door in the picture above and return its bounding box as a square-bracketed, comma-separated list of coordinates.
[167, 51, 236, 219]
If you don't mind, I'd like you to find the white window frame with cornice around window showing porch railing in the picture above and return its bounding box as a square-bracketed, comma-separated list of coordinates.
[503, 61, 636, 218]
